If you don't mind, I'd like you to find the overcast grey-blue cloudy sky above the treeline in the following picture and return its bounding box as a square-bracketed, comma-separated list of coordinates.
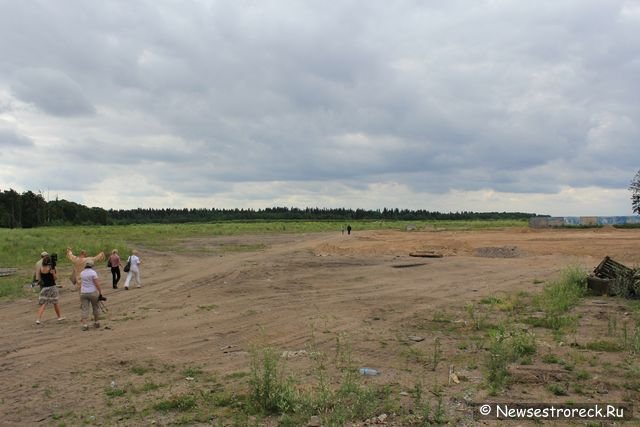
[0, 0, 640, 216]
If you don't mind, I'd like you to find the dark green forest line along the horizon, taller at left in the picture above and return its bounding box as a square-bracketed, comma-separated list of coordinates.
[0, 190, 546, 228]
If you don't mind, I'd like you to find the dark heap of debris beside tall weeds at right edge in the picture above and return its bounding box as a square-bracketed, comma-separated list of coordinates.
[587, 256, 640, 298]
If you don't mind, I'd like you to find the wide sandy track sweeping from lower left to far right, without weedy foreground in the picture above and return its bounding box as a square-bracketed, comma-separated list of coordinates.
[0, 229, 640, 425]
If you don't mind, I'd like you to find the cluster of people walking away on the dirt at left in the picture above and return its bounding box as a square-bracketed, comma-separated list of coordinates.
[34, 248, 142, 331]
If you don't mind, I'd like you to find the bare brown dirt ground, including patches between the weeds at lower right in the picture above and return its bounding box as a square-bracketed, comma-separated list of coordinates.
[0, 228, 640, 426]
